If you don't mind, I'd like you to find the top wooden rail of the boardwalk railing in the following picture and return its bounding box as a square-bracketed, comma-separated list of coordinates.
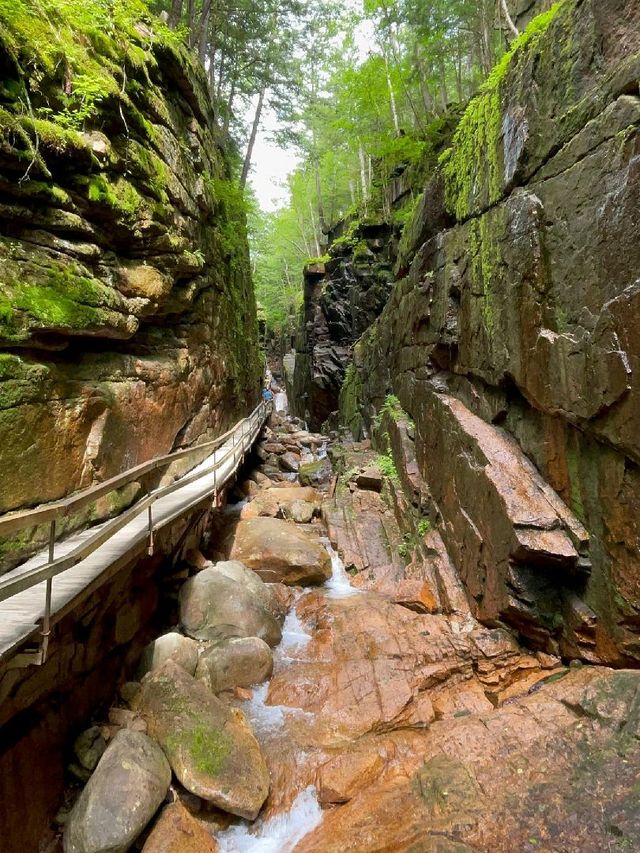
[0, 403, 264, 536]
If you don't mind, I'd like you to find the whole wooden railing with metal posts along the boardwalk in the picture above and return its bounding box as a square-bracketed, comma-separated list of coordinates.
[0, 401, 271, 663]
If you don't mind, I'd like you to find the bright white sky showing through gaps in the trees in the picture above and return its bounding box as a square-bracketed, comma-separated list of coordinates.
[249, 12, 373, 211]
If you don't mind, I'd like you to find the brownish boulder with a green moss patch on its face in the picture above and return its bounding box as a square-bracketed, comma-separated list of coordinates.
[137, 661, 269, 820]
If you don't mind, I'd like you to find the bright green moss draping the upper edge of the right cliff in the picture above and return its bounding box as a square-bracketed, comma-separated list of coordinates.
[440, 0, 567, 220]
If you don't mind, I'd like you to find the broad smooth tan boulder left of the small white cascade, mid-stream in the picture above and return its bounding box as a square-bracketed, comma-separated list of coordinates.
[230, 518, 331, 586]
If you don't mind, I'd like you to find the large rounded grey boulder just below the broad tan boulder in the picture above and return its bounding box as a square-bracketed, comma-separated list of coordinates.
[180, 564, 282, 646]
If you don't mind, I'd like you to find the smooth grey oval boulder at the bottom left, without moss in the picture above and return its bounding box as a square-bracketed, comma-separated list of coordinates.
[64, 724, 171, 853]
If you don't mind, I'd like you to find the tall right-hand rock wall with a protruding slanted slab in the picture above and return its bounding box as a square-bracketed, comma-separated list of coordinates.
[342, 0, 640, 665]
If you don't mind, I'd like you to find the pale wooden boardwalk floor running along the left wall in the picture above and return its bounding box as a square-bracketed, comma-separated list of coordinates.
[0, 413, 264, 661]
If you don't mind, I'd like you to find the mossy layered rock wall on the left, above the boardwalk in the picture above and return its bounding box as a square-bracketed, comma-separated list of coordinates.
[0, 2, 260, 566]
